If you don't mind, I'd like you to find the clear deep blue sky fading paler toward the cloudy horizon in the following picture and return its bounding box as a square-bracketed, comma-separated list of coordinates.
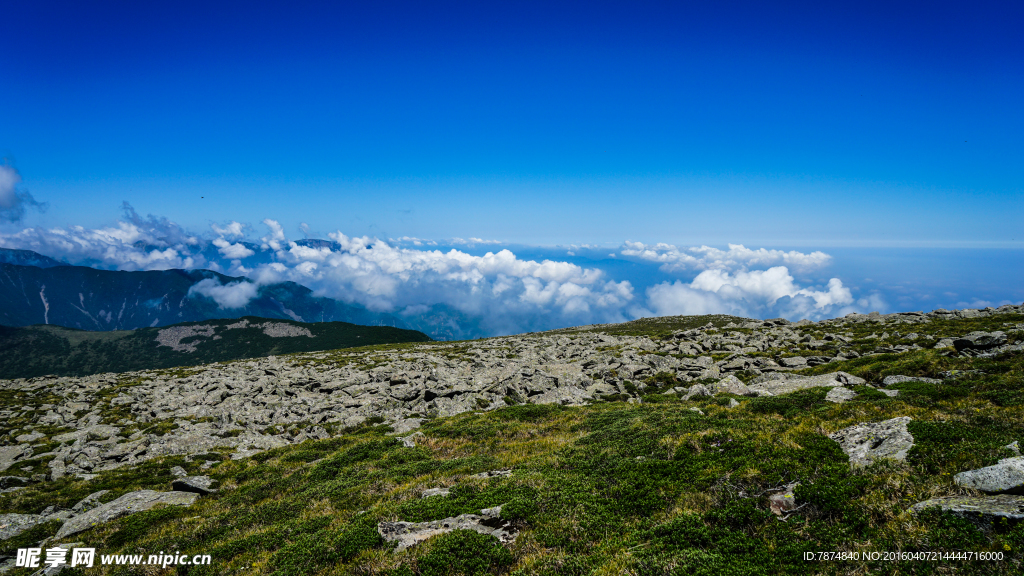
[0, 2, 1024, 332]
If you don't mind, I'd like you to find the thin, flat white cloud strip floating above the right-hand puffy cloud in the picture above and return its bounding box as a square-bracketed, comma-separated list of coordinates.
[620, 241, 831, 272]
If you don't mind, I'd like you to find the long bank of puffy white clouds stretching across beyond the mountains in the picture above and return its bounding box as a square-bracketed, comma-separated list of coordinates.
[0, 203, 884, 335]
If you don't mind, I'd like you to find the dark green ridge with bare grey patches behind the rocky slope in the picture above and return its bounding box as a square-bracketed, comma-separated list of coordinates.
[0, 317, 430, 378]
